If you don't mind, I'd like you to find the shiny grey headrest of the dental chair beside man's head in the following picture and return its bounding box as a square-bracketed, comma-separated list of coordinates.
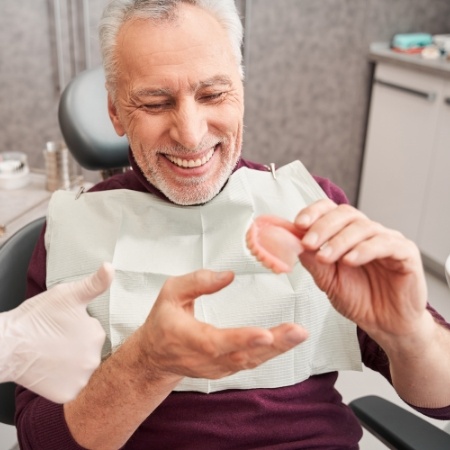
[58, 67, 129, 170]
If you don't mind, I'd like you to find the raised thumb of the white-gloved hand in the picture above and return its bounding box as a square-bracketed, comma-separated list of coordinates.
[70, 262, 114, 305]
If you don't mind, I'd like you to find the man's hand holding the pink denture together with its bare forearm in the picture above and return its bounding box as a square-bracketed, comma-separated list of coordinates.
[295, 200, 450, 408]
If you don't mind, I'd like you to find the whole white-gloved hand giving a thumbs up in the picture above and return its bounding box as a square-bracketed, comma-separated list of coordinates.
[0, 263, 114, 403]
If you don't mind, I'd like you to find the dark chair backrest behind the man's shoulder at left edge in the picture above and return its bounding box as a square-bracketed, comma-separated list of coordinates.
[0, 217, 45, 425]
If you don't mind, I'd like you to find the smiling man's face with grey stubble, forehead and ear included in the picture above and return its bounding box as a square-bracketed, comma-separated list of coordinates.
[109, 5, 244, 205]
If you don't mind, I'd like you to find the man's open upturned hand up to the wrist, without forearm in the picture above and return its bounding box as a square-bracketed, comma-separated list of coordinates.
[137, 270, 307, 380]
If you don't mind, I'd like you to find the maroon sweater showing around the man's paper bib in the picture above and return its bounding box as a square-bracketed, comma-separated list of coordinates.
[16, 156, 450, 450]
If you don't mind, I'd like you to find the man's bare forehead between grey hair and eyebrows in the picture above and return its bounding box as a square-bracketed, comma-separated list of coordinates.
[117, 4, 240, 91]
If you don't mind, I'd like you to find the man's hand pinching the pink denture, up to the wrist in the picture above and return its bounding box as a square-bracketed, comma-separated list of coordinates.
[295, 199, 427, 337]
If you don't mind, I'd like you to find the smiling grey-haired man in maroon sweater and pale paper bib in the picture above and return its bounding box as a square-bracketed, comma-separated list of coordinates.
[17, 0, 450, 450]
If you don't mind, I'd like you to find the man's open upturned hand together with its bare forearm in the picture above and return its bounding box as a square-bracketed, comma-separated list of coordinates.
[64, 270, 307, 448]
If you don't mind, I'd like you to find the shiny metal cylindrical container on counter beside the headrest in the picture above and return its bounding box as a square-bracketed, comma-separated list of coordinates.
[44, 141, 82, 192]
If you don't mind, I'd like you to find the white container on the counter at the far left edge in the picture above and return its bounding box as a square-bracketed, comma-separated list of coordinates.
[0, 152, 30, 190]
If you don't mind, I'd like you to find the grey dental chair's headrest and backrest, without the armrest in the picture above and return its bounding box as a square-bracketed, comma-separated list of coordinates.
[0, 68, 129, 425]
